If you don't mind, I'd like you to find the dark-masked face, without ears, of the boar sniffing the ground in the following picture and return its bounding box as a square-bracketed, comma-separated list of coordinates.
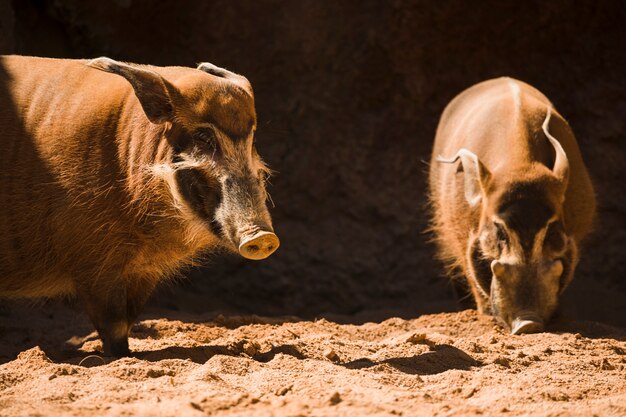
[470, 178, 574, 334]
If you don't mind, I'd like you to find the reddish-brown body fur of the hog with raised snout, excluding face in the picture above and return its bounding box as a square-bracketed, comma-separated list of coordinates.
[0, 56, 271, 354]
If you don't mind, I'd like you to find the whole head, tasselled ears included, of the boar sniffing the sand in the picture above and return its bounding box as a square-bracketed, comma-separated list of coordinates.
[437, 109, 578, 334]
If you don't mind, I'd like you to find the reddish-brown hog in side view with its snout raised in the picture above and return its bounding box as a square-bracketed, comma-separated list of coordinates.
[0, 56, 279, 356]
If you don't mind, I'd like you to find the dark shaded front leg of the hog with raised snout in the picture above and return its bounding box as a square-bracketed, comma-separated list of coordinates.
[78, 278, 130, 357]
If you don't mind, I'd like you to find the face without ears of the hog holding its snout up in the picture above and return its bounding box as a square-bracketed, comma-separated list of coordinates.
[167, 69, 279, 260]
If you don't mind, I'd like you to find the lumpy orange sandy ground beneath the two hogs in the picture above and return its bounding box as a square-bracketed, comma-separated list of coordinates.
[0, 306, 626, 416]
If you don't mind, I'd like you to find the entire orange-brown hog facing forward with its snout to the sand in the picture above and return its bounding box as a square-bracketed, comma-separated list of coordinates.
[430, 78, 595, 334]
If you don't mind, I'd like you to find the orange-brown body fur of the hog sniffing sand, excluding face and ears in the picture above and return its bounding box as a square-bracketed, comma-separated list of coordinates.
[430, 78, 595, 326]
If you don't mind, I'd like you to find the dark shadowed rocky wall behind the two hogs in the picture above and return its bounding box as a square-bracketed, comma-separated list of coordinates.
[0, 0, 626, 326]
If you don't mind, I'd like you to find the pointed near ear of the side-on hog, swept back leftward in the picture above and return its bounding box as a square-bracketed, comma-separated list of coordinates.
[87, 57, 174, 124]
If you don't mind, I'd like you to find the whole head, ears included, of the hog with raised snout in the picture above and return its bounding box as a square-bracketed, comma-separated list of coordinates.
[89, 58, 279, 260]
